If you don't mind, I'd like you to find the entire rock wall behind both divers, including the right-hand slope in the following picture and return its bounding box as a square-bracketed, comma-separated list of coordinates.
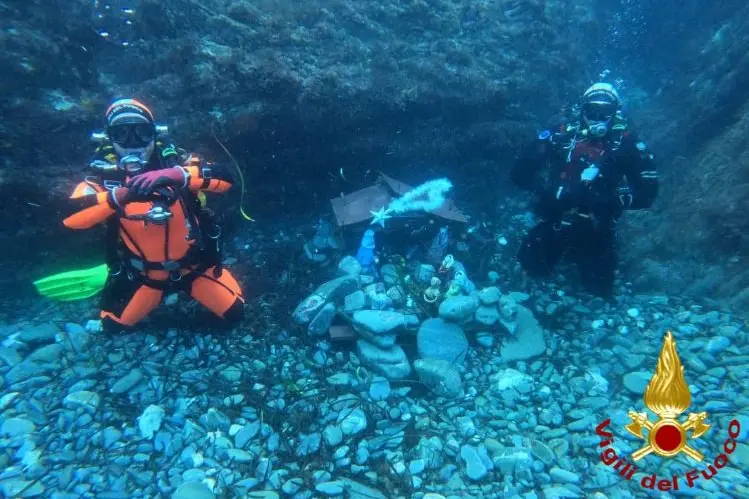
[0, 0, 749, 308]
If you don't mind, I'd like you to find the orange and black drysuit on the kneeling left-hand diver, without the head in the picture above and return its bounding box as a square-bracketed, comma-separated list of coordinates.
[63, 146, 244, 328]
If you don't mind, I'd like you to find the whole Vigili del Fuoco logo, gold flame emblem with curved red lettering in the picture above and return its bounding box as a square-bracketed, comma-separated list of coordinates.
[596, 331, 741, 492]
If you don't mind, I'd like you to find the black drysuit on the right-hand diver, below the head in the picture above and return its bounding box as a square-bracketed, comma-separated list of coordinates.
[510, 119, 658, 298]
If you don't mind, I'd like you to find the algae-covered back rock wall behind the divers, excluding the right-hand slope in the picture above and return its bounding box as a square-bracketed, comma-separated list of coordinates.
[0, 0, 600, 199]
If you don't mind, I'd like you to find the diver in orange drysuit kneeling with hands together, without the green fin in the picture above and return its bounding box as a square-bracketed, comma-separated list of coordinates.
[63, 99, 244, 330]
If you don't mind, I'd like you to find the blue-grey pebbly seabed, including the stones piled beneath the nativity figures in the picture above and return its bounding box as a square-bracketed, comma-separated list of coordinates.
[0, 259, 749, 499]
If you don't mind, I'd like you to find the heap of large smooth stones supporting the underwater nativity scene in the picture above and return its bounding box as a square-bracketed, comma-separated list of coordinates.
[293, 256, 546, 397]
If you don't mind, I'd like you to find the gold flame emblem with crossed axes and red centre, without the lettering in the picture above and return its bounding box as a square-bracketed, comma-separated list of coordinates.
[625, 331, 710, 462]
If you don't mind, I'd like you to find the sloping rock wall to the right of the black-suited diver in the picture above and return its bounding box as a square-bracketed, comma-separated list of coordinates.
[623, 2, 749, 309]
